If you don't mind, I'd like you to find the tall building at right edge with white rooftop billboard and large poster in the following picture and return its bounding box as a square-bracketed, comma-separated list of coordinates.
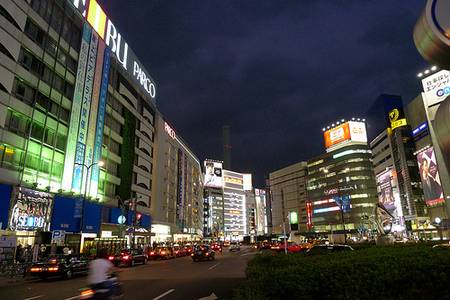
[405, 68, 450, 237]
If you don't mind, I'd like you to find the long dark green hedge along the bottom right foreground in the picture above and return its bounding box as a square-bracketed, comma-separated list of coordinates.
[234, 245, 450, 299]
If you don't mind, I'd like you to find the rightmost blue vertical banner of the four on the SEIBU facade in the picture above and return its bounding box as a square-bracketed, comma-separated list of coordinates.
[90, 48, 111, 196]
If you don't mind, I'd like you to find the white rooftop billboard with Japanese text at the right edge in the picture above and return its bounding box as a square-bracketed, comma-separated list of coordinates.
[422, 70, 450, 106]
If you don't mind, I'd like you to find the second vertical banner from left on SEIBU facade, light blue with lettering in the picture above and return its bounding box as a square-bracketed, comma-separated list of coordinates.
[72, 29, 98, 193]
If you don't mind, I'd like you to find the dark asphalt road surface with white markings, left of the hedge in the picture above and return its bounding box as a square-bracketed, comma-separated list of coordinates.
[0, 248, 256, 300]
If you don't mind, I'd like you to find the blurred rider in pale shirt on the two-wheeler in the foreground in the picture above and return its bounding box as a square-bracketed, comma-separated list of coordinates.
[87, 248, 114, 290]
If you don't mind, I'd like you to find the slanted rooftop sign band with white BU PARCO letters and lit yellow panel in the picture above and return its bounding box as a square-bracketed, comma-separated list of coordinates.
[69, 0, 156, 99]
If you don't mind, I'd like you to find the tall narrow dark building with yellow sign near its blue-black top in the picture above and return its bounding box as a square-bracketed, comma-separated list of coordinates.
[370, 95, 426, 232]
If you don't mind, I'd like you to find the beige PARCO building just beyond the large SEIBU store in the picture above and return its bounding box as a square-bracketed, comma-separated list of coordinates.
[150, 113, 203, 242]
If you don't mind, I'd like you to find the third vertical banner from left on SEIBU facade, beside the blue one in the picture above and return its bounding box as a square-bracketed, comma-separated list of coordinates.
[84, 39, 105, 196]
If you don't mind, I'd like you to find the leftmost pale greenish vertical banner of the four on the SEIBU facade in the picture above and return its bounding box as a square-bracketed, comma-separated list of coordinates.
[62, 24, 91, 191]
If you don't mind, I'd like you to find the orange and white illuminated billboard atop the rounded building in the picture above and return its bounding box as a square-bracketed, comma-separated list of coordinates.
[324, 121, 367, 149]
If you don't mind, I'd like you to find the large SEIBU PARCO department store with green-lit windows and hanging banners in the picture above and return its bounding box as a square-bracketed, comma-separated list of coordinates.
[0, 0, 156, 251]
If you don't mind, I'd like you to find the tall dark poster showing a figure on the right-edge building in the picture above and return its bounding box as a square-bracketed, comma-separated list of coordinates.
[417, 147, 444, 206]
